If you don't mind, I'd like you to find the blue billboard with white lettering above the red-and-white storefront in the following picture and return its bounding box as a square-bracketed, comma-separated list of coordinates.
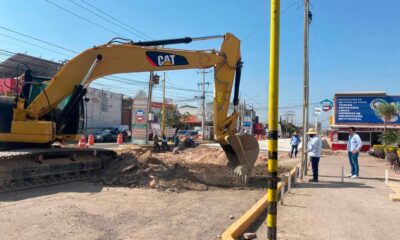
[335, 96, 400, 125]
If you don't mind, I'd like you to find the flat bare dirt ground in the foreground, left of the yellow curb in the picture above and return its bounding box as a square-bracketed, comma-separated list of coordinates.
[0, 182, 265, 240]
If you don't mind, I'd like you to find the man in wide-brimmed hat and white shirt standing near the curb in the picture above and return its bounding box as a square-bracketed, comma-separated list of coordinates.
[306, 128, 322, 182]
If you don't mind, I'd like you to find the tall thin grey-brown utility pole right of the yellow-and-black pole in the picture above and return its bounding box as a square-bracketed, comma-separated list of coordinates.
[300, 0, 312, 180]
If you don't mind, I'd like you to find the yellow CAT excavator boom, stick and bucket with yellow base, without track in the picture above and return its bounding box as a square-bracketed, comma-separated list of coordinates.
[0, 33, 259, 177]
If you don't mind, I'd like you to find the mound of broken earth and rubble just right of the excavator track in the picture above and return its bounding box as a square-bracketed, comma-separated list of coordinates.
[93, 150, 207, 192]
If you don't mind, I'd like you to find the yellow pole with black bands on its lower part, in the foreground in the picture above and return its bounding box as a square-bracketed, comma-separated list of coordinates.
[266, 0, 280, 240]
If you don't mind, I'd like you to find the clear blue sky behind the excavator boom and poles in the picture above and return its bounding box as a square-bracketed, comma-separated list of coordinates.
[0, 0, 400, 124]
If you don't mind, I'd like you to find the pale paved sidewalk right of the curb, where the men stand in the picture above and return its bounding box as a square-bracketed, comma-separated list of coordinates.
[257, 153, 400, 240]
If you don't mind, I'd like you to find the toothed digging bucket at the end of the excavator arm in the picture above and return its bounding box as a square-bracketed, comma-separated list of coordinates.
[221, 134, 260, 183]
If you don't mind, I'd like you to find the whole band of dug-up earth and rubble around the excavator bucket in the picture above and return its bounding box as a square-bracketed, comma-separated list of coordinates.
[91, 145, 297, 192]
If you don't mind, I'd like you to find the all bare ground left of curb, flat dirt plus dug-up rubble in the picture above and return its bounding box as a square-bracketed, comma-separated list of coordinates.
[0, 145, 299, 240]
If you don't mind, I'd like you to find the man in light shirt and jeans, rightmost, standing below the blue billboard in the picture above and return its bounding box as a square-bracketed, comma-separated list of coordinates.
[347, 127, 362, 178]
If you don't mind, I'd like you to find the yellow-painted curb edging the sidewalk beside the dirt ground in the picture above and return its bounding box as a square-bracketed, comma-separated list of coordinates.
[221, 163, 300, 240]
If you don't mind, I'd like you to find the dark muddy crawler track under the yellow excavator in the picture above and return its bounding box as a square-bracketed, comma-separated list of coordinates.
[0, 148, 116, 193]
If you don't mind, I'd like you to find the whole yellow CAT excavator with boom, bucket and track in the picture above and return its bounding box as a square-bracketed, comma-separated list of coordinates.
[0, 33, 259, 191]
